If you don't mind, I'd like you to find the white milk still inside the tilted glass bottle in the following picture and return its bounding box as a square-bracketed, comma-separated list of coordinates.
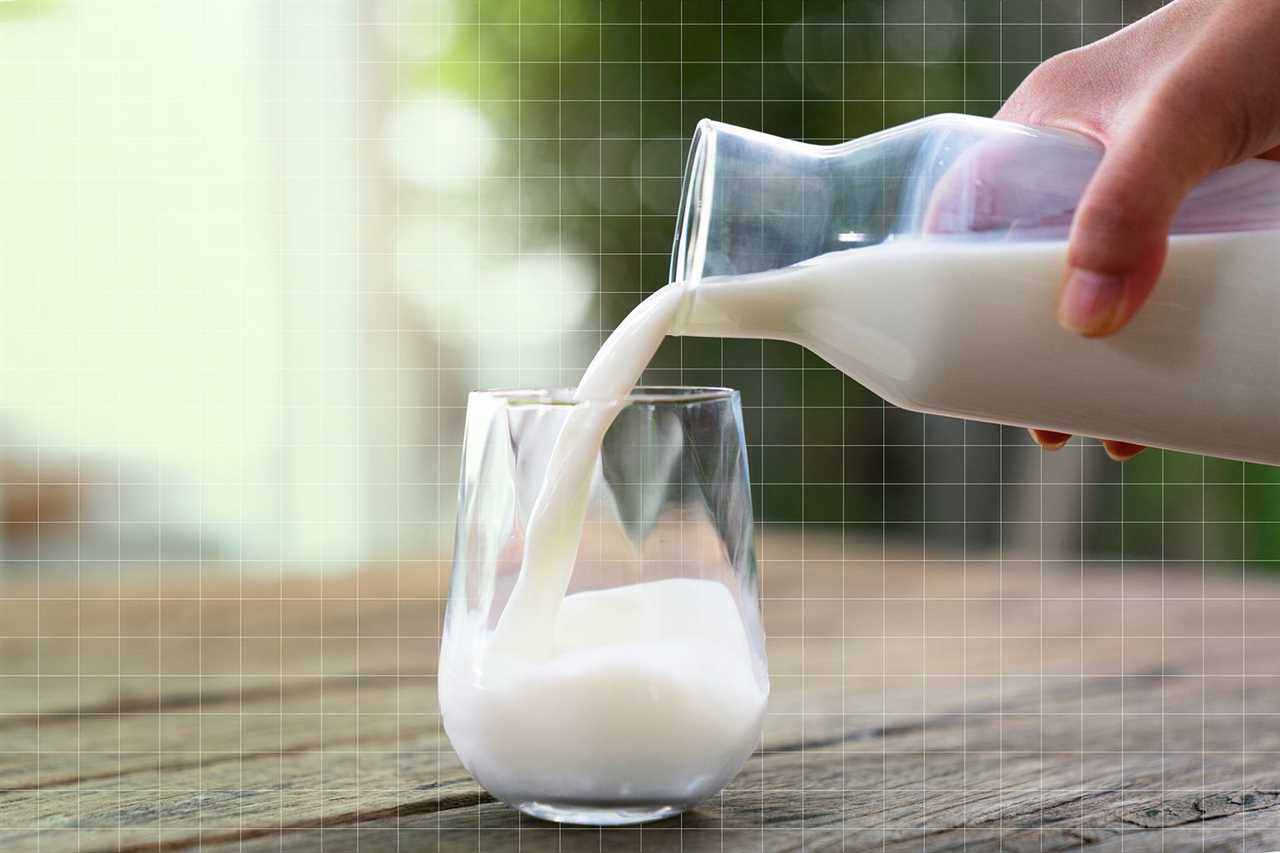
[672, 232, 1280, 464]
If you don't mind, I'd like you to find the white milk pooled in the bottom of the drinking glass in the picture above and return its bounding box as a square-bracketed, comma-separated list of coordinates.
[440, 579, 767, 822]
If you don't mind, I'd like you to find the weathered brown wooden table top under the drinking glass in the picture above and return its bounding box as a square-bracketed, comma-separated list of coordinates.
[0, 534, 1280, 852]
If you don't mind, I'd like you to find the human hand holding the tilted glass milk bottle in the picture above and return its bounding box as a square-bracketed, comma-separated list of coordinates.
[996, 0, 1280, 460]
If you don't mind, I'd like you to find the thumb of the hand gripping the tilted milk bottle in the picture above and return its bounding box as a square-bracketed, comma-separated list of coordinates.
[1057, 113, 1221, 337]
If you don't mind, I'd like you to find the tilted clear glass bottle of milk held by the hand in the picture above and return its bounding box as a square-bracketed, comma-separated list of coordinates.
[672, 115, 1280, 464]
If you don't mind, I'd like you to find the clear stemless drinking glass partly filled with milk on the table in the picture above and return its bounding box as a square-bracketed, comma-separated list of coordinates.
[439, 387, 768, 825]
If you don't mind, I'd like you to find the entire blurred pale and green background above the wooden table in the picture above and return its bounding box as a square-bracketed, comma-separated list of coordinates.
[0, 0, 1280, 567]
